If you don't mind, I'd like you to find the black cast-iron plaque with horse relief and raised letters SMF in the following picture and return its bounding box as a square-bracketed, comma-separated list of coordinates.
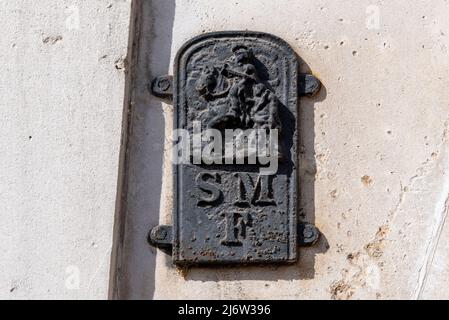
[150, 31, 319, 265]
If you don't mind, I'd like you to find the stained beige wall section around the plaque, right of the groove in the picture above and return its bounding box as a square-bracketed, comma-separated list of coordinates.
[118, 0, 449, 299]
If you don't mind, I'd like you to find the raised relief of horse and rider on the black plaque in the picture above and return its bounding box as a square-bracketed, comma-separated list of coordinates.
[195, 45, 281, 131]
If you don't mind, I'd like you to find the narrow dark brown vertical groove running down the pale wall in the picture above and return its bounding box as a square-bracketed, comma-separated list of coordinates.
[108, 0, 142, 299]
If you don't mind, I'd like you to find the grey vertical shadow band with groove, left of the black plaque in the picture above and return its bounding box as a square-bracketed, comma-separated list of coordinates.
[110, 0, 176, 299]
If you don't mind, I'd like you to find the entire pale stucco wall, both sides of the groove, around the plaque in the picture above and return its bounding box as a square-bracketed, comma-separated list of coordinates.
[0, 0, 449, 299]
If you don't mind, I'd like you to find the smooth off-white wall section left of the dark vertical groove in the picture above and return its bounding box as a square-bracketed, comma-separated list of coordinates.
[0, 0, 131, 299]
